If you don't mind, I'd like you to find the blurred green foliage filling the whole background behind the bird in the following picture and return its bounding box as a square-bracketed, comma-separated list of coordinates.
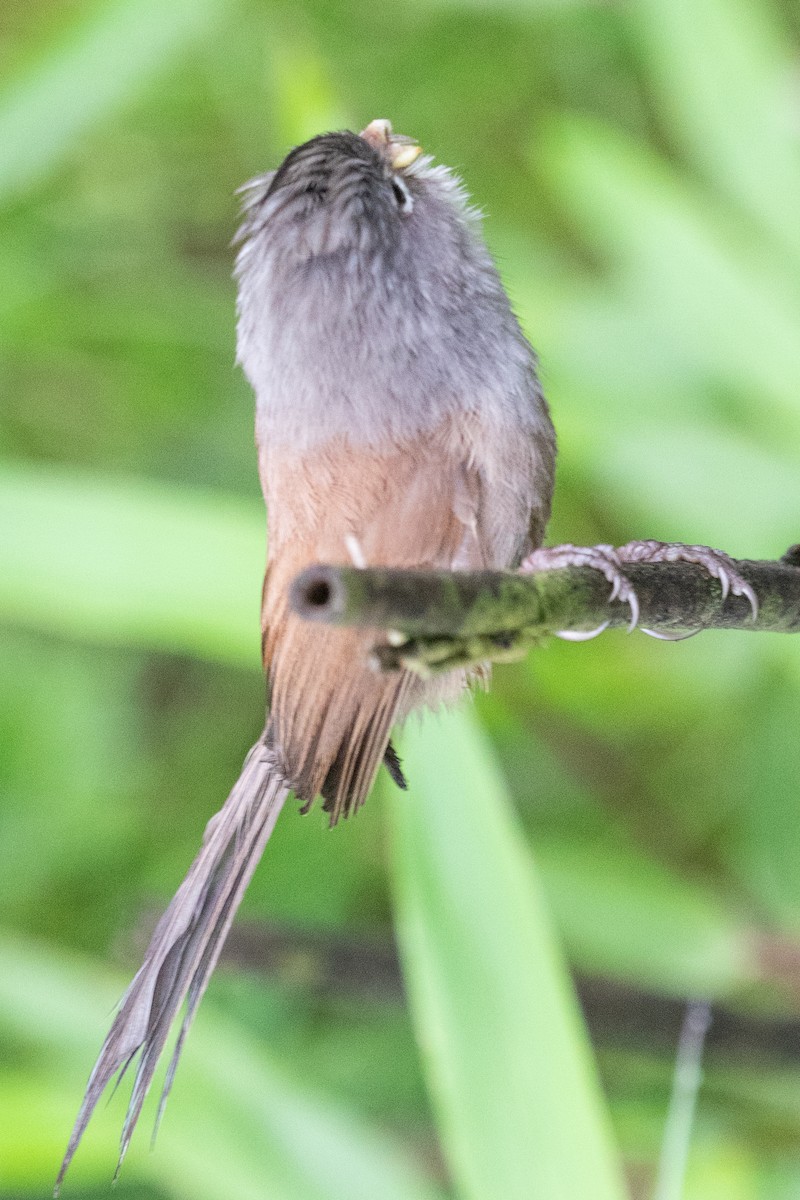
[0, 0, 800, 1200]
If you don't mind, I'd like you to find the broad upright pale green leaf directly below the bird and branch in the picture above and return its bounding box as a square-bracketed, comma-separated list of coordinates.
[392, 710, 625, 1200]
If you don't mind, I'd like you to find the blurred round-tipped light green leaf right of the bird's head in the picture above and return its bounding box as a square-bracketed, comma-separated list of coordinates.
[541, 119, 800, 428]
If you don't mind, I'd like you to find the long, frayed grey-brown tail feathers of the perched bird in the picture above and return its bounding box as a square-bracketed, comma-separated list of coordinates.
[55, 742, 289, 1196]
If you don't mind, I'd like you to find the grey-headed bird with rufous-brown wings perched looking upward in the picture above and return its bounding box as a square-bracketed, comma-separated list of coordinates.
[56, 119, 556, 1194]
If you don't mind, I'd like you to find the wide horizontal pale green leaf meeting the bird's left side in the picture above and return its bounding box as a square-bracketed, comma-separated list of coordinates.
[0, 467, 265, 667]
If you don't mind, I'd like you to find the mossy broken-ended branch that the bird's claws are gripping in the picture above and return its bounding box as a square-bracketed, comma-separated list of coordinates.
[289, 546, 800, 676]
